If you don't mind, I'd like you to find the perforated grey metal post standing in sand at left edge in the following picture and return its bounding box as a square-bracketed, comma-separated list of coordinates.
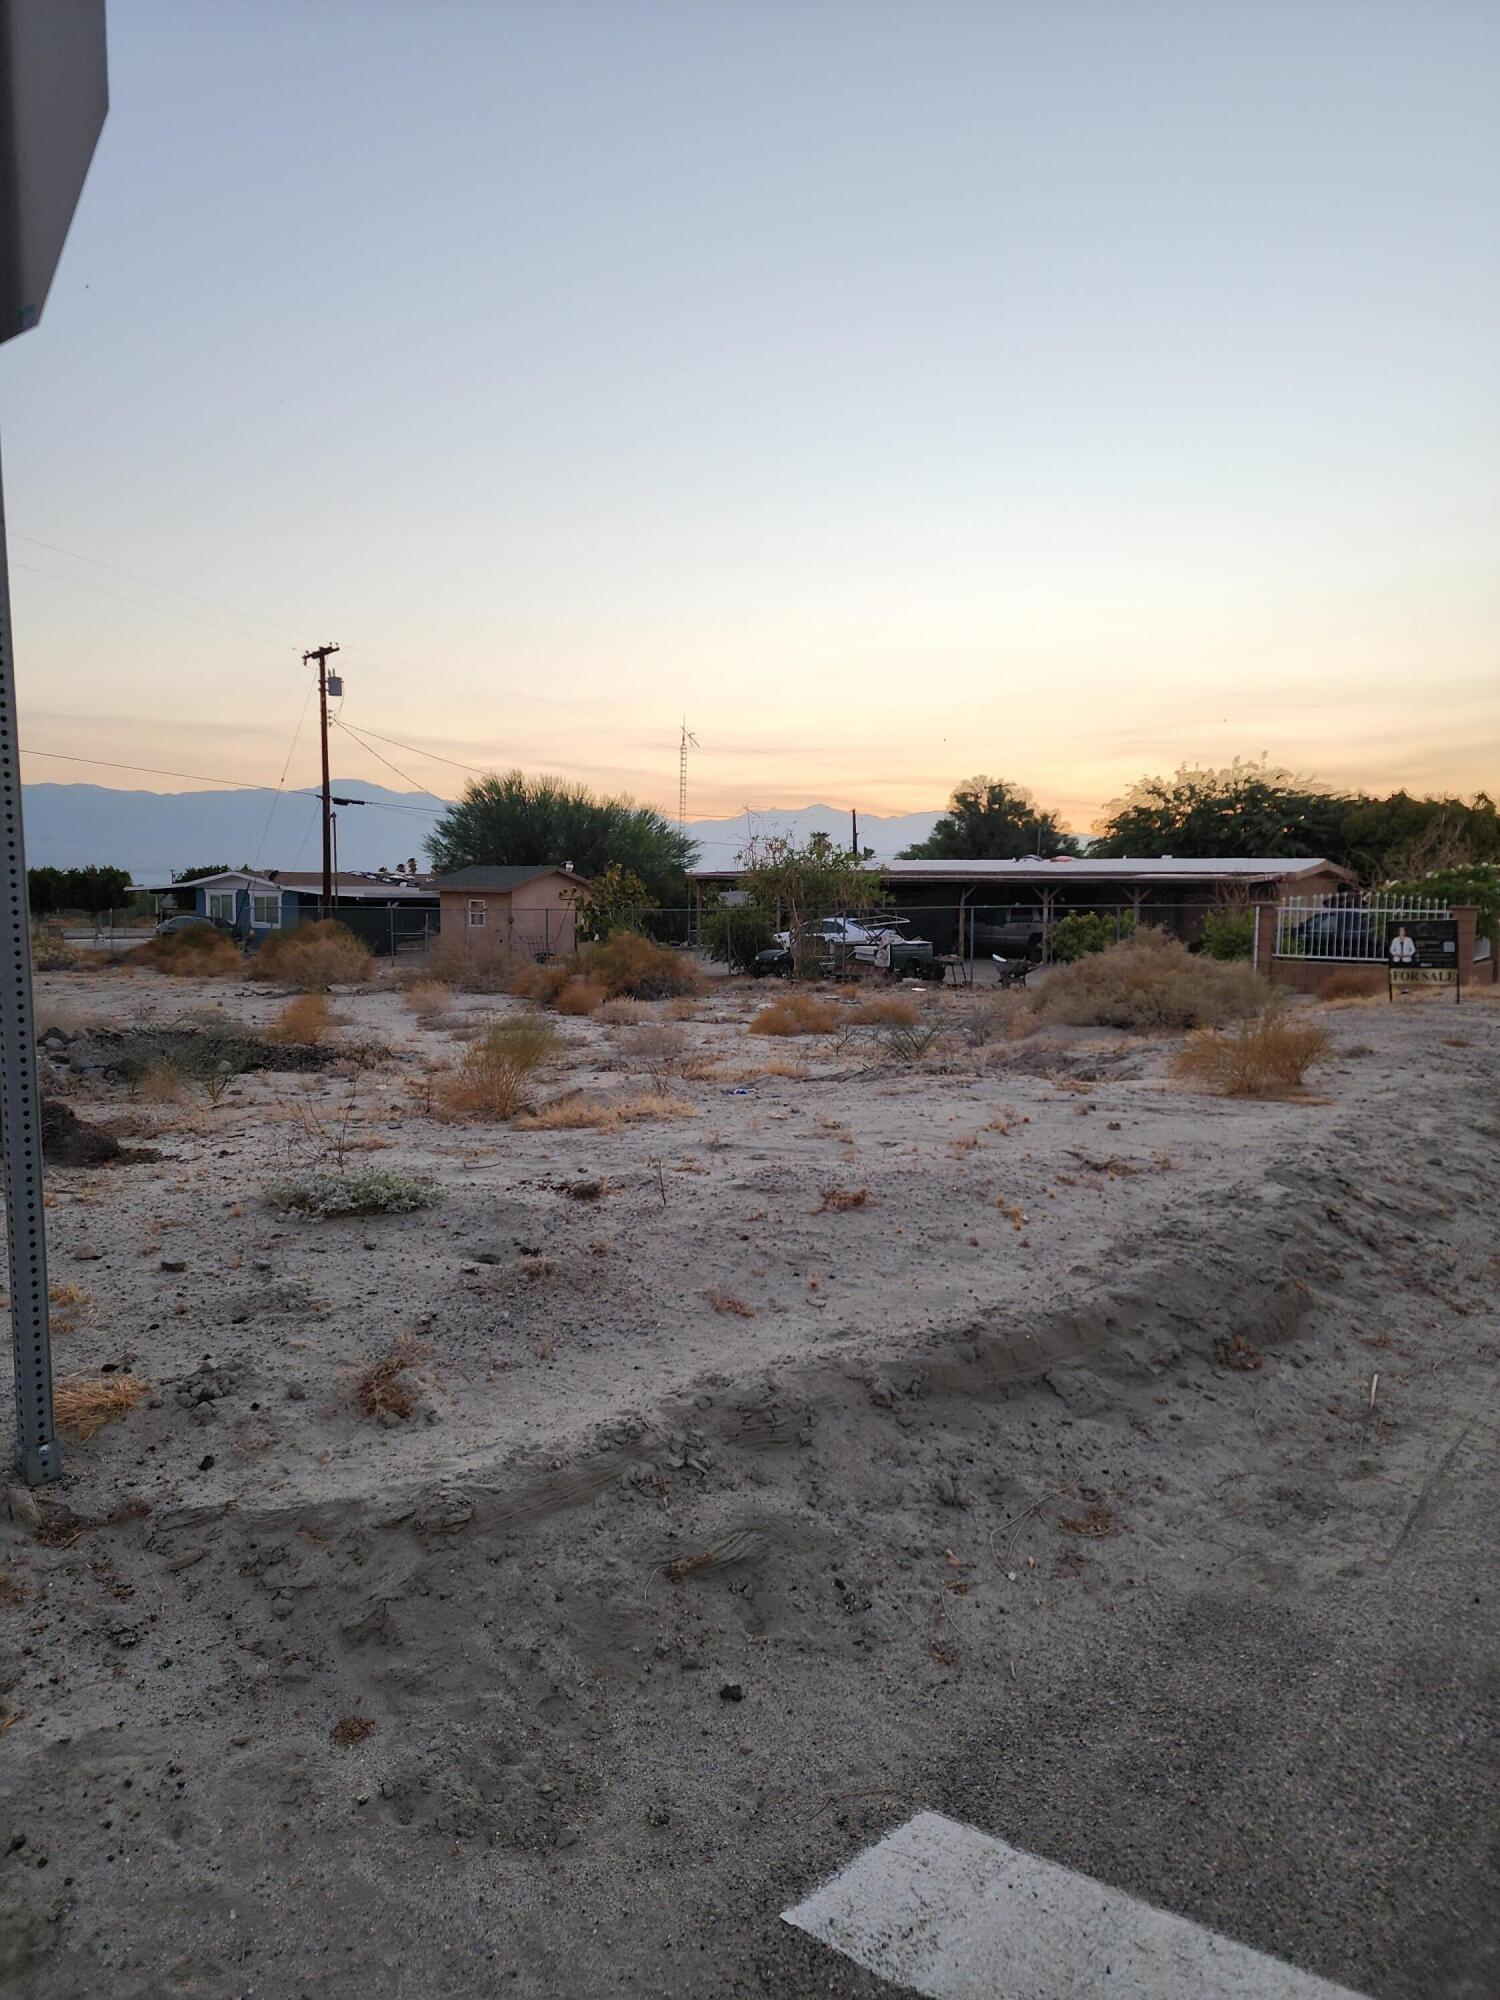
[0, 450, 62, 1486]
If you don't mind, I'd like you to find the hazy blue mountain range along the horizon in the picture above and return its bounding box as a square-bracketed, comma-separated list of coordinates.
[22, 778, 938, 882]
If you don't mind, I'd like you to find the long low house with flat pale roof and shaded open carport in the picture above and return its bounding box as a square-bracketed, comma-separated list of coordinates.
[688, 854, 1356, 952]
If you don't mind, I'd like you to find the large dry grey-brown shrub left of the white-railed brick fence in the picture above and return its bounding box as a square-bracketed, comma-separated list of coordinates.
[1024, 928, 1270, 1030]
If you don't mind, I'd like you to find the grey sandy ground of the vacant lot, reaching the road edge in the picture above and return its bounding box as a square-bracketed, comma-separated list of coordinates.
[0, 972, 1500, 2000]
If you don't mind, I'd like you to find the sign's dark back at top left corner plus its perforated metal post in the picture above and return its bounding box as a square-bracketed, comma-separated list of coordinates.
[0, 0, 108, 1486]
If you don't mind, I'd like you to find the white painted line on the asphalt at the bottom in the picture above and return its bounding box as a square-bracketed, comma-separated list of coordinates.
[782, 1812, 1360, 2000]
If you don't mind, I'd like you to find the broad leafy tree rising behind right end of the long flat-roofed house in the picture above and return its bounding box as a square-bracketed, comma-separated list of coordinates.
[1090, 758, 1346, 860]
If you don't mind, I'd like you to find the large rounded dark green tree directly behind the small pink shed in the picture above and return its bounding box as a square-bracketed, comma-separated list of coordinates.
[428, 770, 698, 902]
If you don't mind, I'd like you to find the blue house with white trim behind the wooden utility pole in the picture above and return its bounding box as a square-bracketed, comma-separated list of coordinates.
[132, 868, 438, 954]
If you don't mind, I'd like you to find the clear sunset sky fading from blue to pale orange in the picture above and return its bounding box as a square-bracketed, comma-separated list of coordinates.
[0, 0, 1500, 830]
